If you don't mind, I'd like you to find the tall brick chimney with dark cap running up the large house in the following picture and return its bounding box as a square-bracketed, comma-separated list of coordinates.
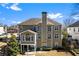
[41, 12, 47, 46]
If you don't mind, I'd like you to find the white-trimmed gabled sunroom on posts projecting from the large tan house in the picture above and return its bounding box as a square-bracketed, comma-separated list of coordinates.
[20, 30, 37, 52]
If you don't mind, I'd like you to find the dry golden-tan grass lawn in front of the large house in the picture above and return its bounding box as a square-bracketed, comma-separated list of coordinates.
[35, 50, 72, 56]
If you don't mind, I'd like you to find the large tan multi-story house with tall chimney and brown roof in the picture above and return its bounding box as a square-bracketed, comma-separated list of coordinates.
[18, 12, 62, 51]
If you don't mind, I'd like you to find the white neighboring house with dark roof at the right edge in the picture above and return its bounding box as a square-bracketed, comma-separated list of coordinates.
[67, 21, 79, 40]
